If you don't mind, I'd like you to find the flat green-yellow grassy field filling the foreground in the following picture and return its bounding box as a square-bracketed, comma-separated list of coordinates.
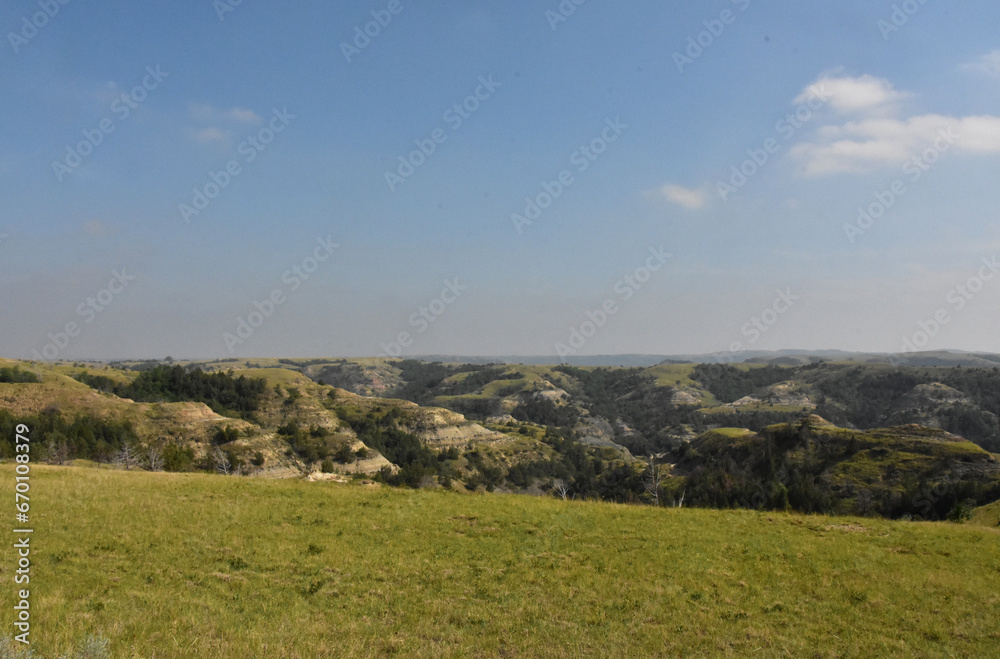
[0, 464, 1000, 657]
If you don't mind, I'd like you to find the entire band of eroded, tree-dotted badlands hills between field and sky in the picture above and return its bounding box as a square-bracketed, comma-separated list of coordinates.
[0, 359, 1000, 520]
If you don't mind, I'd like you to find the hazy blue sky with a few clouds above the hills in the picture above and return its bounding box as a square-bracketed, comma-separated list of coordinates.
[0, 0, 1000, 360]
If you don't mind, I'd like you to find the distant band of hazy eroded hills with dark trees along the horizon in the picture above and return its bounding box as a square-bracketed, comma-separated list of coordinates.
[160, 358, 1000, 455]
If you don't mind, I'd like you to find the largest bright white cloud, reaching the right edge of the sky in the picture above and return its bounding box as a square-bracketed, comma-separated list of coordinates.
[790, 76, 1000, 176]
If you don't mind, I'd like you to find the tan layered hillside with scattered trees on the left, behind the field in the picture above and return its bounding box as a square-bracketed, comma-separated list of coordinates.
[0, 360, 635, 500]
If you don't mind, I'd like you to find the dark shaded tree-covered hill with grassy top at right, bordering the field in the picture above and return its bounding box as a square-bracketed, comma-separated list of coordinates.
[666, 415, 1000, 519]
